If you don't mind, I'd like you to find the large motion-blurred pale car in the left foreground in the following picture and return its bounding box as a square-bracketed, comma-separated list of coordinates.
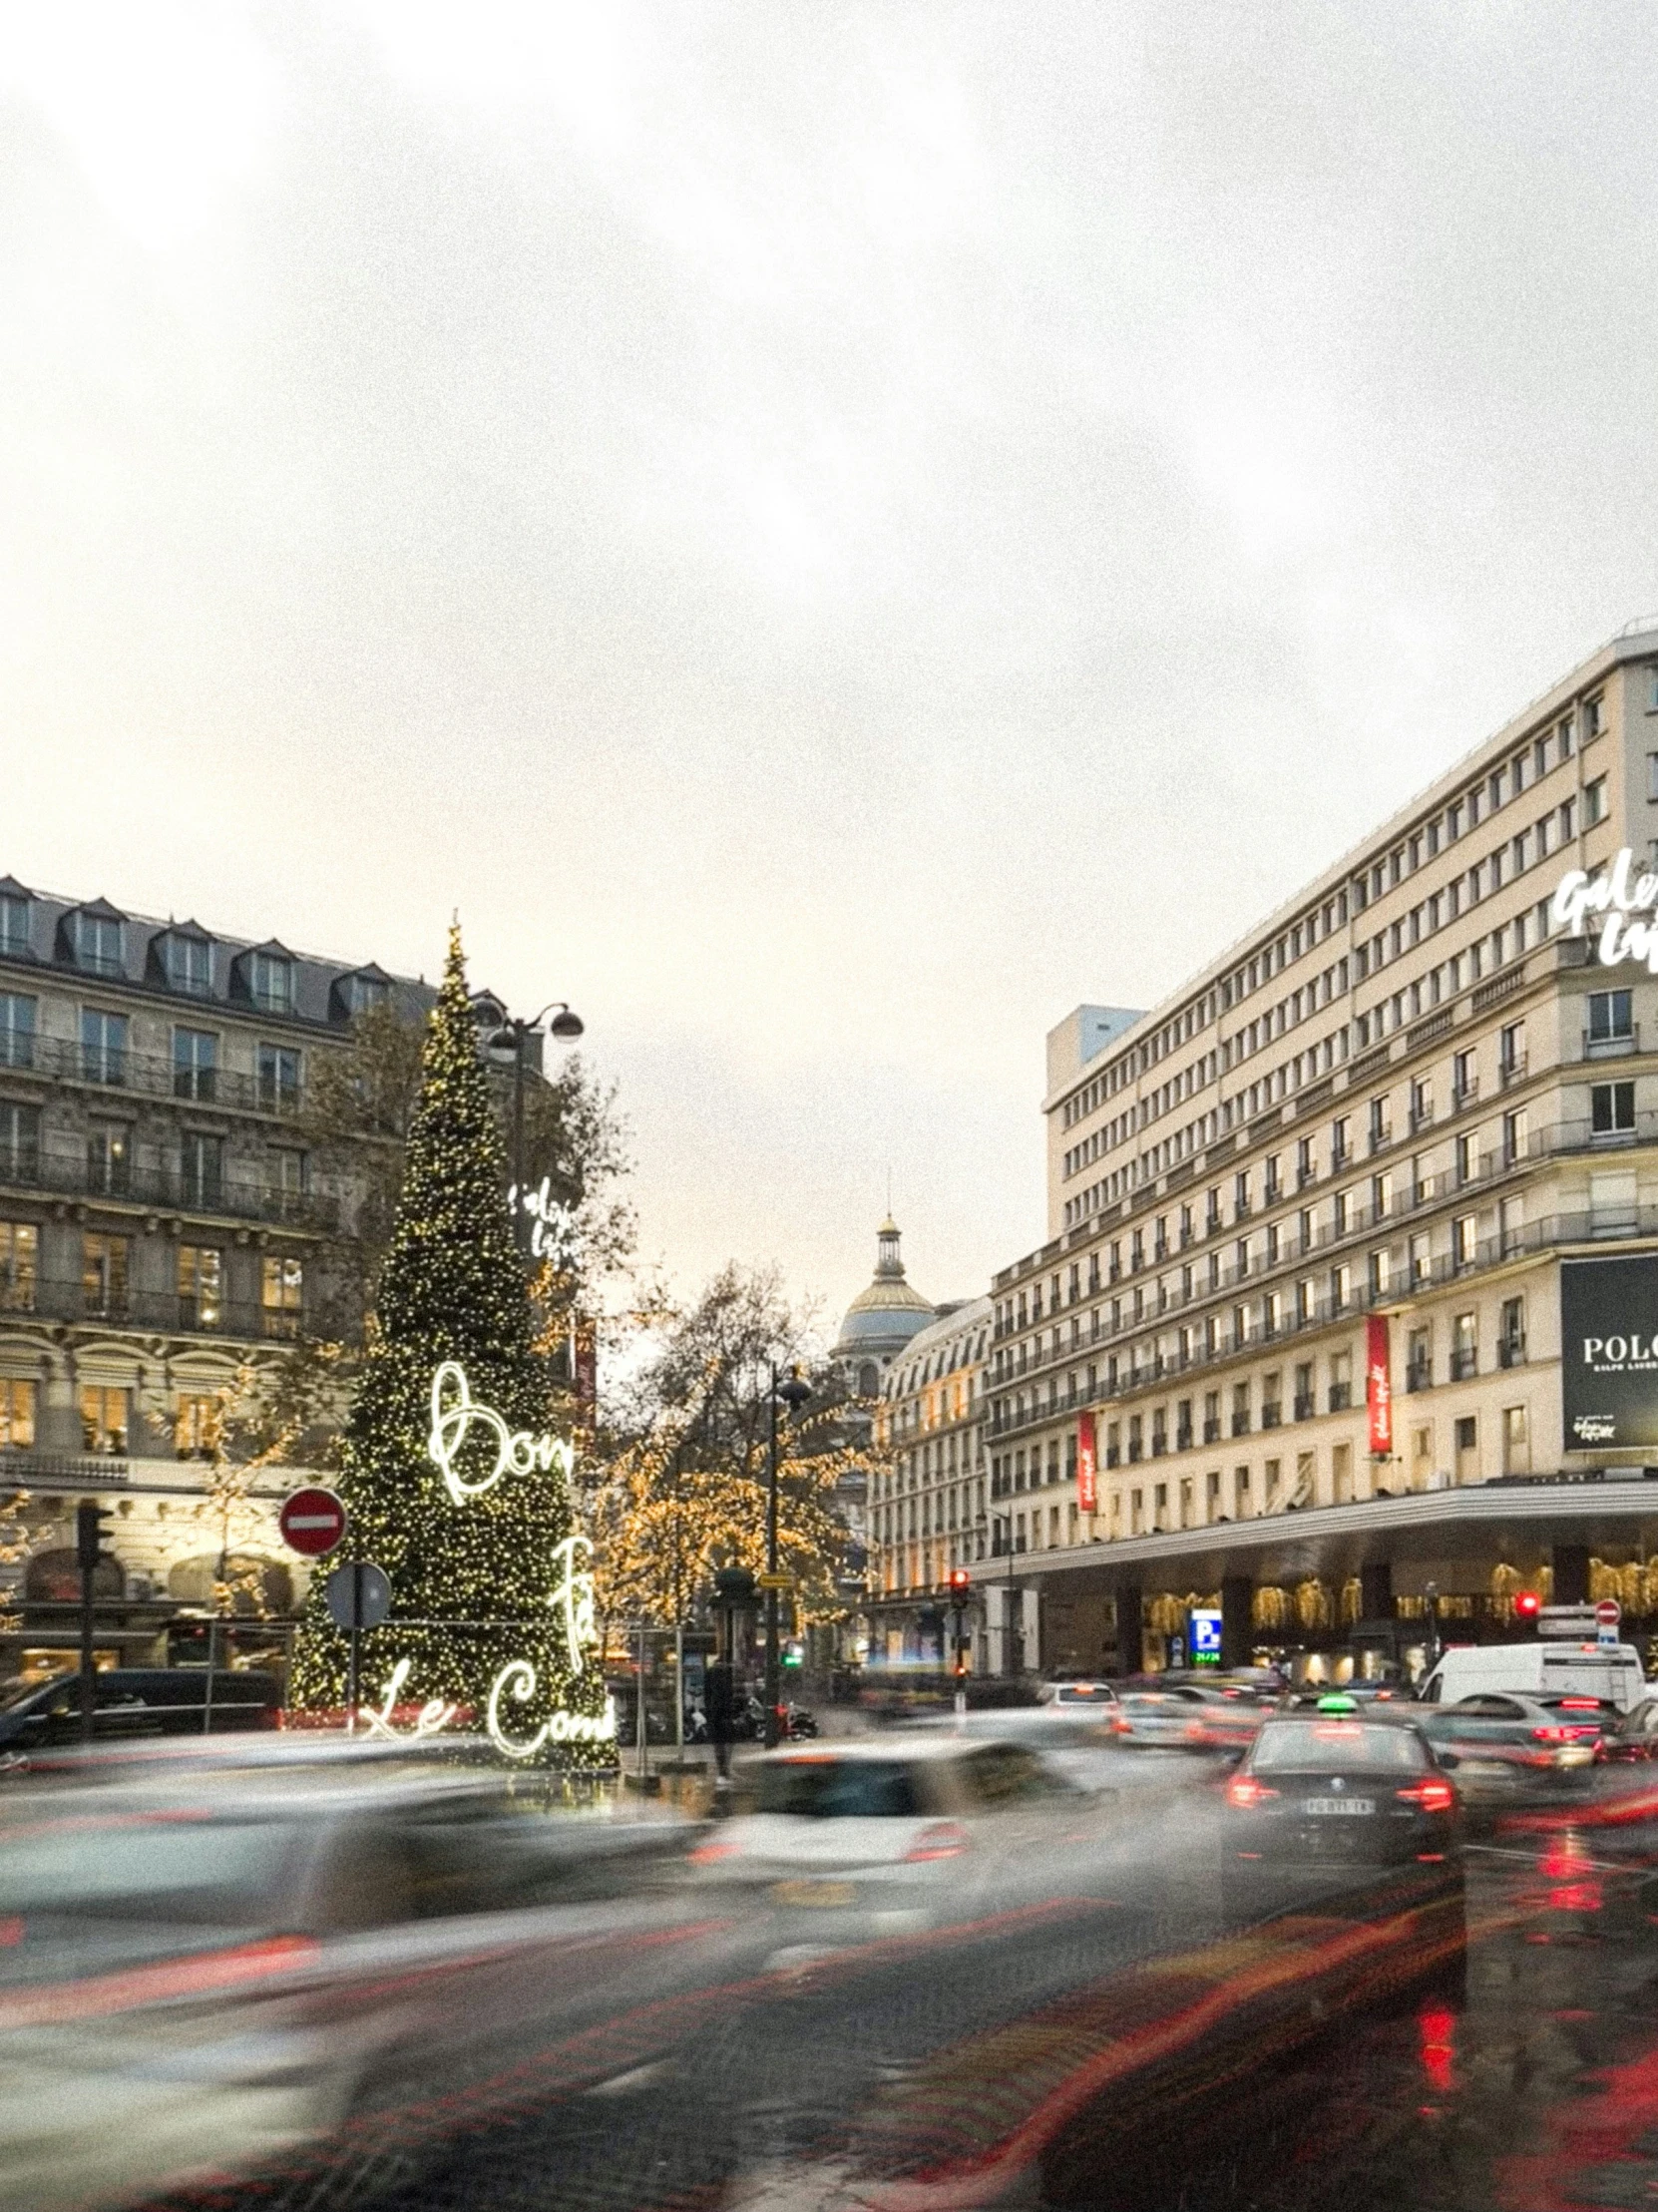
[0, 1745, 689, 2212]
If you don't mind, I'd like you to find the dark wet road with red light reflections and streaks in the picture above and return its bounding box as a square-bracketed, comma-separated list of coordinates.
[324, 1792, 1658, 2212]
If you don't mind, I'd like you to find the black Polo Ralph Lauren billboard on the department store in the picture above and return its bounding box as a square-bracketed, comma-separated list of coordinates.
[1560, 1252, 1658, 1451]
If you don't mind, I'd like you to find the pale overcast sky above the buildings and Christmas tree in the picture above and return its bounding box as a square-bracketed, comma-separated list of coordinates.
[0, 0, 1658, 1318]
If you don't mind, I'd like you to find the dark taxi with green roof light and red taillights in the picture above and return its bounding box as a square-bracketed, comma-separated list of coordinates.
[1222, 1712, 1463, 1909]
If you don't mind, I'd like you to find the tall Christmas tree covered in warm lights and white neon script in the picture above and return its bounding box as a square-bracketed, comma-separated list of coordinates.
[289, 927, 615, 1765]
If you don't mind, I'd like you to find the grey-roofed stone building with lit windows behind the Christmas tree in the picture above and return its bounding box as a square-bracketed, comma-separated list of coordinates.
[0, 878, 433, 1676]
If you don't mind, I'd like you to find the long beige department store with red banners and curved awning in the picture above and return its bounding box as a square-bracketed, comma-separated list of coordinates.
[980, 626, 1658, 1670]
